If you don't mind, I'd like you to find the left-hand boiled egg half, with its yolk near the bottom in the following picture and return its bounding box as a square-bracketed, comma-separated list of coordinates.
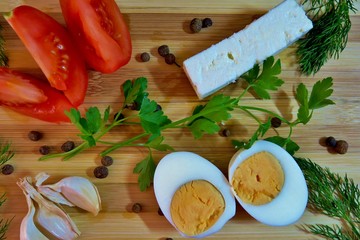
[154, 152, 236, 238]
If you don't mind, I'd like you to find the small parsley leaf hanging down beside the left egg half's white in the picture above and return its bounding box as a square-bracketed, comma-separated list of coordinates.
[133, 152, 156, 191]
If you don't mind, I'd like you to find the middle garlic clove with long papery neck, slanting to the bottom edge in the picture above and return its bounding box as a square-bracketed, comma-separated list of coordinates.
[18, 178, 80, 240]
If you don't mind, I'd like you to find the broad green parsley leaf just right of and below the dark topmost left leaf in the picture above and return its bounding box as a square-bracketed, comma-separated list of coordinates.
[139, 98, 171, 136]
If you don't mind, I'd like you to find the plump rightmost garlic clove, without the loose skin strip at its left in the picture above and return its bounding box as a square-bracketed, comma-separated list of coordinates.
[42, 176, 101, 216]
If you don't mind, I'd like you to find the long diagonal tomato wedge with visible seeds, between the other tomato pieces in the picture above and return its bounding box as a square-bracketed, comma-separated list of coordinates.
[5, 5, 88, 106]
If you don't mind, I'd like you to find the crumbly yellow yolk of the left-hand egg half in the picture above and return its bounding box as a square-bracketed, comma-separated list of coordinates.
[170, 180, 225, 236]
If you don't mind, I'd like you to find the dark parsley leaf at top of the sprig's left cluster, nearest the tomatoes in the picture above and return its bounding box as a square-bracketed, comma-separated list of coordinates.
[122, 77, 149, 107]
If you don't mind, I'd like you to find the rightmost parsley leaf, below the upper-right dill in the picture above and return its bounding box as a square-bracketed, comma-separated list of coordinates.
[295, 77, 335, 125]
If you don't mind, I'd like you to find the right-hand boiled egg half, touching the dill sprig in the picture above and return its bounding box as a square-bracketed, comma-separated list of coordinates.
[229, 140, 308, 226]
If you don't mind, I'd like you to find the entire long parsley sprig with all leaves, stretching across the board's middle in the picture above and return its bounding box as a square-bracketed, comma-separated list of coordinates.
[40, 57, 333, 190]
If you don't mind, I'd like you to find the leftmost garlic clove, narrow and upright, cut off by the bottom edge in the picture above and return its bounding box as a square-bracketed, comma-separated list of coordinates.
[20, 192, 48, 240]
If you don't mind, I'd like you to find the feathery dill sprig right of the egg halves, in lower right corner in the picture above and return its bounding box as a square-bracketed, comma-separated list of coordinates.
[295, 158, 360, 240]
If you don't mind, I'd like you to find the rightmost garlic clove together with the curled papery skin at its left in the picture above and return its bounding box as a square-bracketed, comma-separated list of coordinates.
[36, 173, 101, 216]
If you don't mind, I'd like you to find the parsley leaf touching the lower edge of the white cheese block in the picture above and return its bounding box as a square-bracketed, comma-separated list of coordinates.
[241, 56, 284, 99]
